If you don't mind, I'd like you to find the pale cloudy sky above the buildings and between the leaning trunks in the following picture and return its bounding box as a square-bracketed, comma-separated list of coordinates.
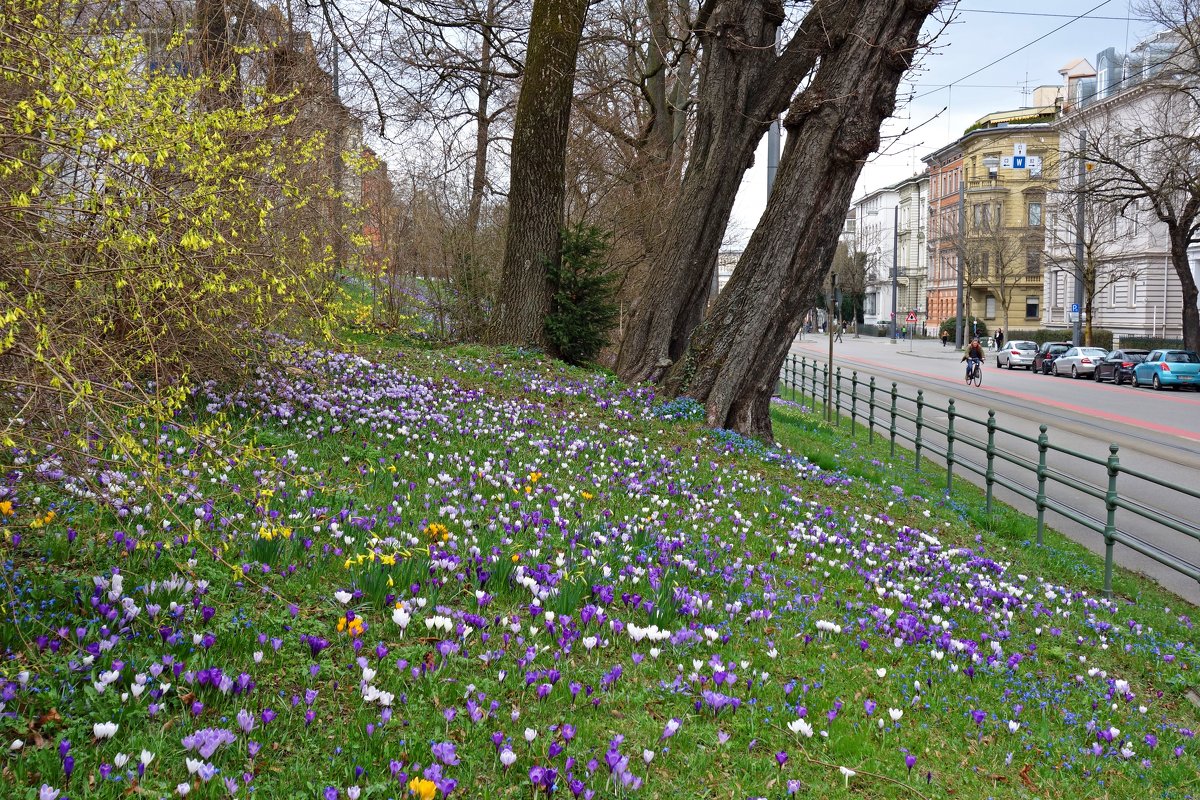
[726, 0, 1156, 247]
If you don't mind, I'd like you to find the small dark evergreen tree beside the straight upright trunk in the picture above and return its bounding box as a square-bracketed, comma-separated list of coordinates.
[546, 222, 617, 365]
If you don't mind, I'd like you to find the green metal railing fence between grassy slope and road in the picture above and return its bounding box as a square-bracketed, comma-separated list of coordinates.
[780, 355, 1200, 596]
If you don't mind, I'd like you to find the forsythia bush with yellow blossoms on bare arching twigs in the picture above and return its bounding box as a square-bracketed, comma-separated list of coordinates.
[0, 0, 350, 455]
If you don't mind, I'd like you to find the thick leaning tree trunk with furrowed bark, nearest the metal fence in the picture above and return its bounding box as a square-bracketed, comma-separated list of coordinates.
[666, 0, 937, 437]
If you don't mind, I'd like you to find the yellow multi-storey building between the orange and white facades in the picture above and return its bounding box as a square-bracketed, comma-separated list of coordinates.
[955, 100, 1060, 333]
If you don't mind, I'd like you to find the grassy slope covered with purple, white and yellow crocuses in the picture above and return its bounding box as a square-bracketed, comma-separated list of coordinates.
[0, 341, 1200, 800]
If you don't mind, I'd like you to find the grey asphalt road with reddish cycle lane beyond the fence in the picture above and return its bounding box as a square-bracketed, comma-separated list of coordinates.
[792, 333, 1200, 606]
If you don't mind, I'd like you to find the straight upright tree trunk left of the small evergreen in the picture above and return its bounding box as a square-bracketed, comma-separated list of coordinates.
[488, 0, 588, 347]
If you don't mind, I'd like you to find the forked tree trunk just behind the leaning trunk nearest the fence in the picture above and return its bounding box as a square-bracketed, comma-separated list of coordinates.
[616, 0, 870, 381]
